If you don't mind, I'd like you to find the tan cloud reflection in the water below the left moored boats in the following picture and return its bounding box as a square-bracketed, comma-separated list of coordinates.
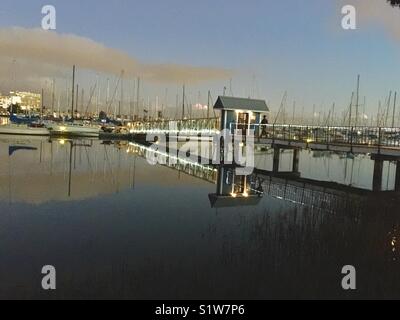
[0, 136, 135, 204]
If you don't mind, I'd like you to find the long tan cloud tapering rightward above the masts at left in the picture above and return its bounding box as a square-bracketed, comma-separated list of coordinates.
[0, 27, 231, 84]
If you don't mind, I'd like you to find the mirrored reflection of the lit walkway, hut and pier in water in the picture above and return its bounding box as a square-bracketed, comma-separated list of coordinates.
[128, 143, 397, 213]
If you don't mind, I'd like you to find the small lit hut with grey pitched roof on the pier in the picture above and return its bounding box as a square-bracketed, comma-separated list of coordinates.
[214, 96, 269, 136]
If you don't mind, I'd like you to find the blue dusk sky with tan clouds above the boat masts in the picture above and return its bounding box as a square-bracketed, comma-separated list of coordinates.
[0, 0, 400, 117]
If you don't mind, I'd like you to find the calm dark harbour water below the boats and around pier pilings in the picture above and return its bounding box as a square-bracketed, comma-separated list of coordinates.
[0, 136, 400, 299]
